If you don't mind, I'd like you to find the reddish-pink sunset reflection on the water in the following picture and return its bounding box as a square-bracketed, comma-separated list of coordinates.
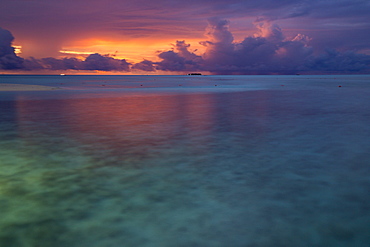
[17, 93, 268, 169]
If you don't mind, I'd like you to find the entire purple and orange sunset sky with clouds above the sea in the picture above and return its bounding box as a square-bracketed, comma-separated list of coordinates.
[0, 0, 370, 74]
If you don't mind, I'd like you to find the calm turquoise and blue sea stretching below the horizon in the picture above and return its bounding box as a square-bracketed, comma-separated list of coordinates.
[0, 75, 370, 247]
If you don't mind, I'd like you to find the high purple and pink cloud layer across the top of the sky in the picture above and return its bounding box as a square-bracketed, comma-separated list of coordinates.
[0, 0, 370, 58]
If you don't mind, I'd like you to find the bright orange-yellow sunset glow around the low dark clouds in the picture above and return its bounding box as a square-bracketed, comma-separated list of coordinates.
[7, 38, 206, 75]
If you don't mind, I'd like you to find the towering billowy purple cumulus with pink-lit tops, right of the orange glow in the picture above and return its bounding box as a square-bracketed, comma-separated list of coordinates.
[157, 19, 312, 74]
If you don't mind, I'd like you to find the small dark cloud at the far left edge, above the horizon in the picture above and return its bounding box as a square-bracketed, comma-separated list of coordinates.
[0, 28, 23, 70]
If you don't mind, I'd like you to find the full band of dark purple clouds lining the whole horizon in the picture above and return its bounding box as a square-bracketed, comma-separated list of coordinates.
[0, 18, 370, 74]
